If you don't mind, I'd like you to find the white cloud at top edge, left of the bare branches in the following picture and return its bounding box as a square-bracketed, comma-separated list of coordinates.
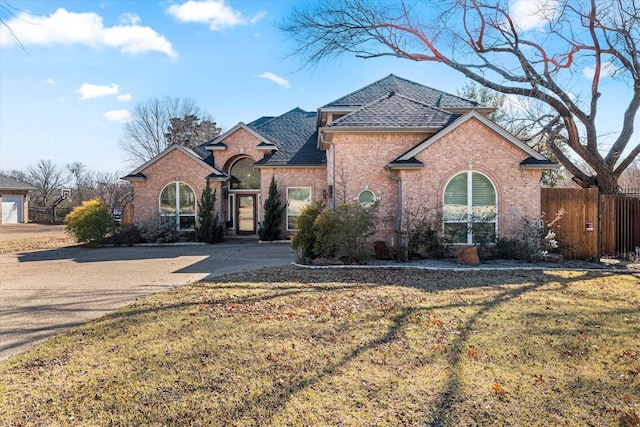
[167, 0, 265, 31]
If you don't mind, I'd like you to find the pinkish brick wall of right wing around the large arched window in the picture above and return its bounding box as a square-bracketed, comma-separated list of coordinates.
[329, 120, 542, 242]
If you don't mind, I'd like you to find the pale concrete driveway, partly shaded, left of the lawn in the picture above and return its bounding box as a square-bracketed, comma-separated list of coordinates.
[0, 240, 294, 360]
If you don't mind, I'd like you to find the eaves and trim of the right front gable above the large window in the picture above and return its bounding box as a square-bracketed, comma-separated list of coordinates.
[388, 110, 558, 169]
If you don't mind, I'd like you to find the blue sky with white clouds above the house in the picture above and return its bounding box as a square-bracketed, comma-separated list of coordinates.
[0, 0, 637, 174]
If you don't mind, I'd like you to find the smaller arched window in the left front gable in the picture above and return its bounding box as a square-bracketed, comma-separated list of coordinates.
[160, 181, 196, 230]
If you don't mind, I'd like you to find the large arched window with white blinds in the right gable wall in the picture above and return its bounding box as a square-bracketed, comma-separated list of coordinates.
[443, 171, 498, 244]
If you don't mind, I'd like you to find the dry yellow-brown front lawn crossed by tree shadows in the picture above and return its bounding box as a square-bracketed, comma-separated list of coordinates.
[0, 267, 640, 426]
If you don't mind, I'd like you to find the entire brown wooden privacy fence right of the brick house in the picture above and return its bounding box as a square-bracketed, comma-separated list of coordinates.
[542, 188, 640, 259]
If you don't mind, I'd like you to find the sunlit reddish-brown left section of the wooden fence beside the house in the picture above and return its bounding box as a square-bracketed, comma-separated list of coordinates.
[542, 188, 599, 259]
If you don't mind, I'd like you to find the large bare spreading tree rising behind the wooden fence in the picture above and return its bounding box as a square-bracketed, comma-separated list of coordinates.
[280, 0, 640, 192]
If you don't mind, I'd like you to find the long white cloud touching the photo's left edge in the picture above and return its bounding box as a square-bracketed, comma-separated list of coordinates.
[0, 8, 177, 58]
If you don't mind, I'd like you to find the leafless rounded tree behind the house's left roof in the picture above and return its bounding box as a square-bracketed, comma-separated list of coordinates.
[120, 97, 218, 165]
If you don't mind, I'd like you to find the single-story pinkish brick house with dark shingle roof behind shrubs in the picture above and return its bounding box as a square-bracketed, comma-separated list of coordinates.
[123, 75, 557, 245]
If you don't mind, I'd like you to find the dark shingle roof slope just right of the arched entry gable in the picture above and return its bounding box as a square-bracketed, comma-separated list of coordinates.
[247, 108, 326, 166]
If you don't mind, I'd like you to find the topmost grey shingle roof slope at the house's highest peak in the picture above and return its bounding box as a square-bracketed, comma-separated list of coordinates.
[322, 74, 482, 110]
